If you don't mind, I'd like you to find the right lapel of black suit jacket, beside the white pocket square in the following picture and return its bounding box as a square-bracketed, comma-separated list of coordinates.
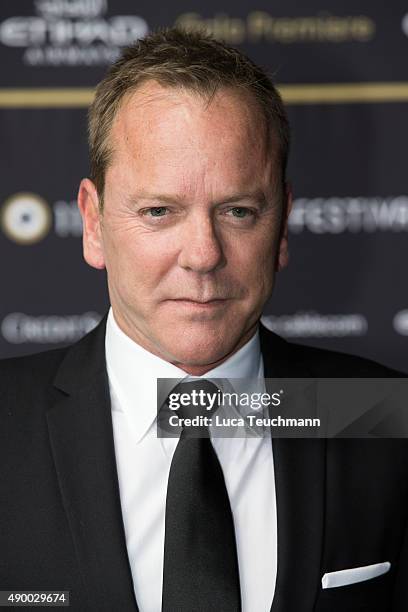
[260, 326, 326, 612]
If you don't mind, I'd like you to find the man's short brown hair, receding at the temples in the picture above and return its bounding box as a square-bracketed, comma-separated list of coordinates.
[88, 28, 290, 206]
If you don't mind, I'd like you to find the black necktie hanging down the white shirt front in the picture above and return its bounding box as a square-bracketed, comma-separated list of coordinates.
[162, 380, 241, 612]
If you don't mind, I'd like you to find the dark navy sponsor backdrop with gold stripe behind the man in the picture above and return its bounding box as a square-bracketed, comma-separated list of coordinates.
[0, 0, 408, 370]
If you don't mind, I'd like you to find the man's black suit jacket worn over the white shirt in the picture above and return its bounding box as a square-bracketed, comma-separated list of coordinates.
[0, 317, 408, 612]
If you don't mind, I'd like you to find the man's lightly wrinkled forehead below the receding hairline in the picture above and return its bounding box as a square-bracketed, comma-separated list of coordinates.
[110, 81, 277, 171]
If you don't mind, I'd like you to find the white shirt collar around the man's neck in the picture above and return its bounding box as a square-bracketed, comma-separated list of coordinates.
[105, 308, 263, 442]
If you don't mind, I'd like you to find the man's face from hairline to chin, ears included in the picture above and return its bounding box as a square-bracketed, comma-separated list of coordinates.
[79, 81, 287, 374]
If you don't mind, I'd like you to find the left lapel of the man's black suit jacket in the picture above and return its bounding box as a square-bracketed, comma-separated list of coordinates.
[47, 318, 137, 612]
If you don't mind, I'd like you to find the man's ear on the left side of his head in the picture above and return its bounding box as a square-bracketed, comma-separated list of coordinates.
[78, 178, 105, 270]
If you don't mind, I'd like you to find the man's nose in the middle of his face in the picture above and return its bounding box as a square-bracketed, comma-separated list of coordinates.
[178, 214, 225, 274]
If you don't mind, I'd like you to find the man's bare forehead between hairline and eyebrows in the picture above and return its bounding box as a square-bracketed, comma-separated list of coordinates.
[108, 81, 274, 192]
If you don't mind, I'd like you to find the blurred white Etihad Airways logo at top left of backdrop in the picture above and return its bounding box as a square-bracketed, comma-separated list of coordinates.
[0, 0, 149, 66]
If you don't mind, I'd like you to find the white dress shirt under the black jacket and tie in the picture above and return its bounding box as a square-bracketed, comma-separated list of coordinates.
[105, 310, 277, 612]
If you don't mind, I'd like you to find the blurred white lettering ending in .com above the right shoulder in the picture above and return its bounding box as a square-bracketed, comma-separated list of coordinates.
[261, 312, 368, 338]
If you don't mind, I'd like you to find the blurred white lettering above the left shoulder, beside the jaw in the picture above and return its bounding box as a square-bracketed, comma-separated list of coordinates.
[1, 312, 101, 344]
